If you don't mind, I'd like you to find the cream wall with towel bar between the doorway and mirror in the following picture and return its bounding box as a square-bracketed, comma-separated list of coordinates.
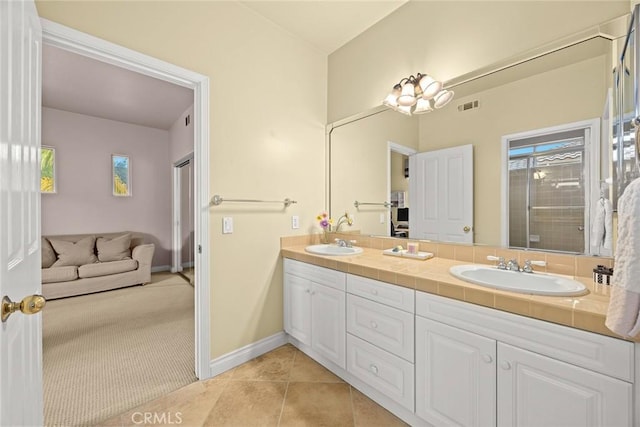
[36, 1, 327, 358]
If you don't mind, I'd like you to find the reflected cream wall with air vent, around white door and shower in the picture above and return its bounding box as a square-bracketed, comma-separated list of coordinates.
[419, 56, 608, 245]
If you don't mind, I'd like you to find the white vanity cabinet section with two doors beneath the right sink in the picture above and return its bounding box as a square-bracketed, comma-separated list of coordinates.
[416, 292, 634, 427]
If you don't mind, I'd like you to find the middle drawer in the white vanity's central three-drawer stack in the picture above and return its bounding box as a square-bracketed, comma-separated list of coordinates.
[347, 294, 414, 362]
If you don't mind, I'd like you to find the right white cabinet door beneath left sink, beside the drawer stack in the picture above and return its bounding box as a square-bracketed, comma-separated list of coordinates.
[311, 283, 346, 368]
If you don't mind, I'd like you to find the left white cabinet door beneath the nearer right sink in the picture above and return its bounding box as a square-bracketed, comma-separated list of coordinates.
[416, 317, 496, 427]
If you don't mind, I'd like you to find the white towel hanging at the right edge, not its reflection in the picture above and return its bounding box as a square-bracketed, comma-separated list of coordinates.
[605, 179, 640, 338]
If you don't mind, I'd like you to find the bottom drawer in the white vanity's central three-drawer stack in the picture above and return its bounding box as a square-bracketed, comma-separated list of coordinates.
[347, 334, 414, 412]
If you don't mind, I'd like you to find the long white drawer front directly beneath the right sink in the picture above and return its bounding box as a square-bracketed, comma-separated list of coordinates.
[416, 292, 634, 382]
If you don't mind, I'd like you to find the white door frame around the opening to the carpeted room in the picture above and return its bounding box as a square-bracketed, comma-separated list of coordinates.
[40, 18, 211, 380]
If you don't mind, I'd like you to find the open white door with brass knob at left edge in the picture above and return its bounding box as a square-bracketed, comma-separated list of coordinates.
[0, 0, 44, 426]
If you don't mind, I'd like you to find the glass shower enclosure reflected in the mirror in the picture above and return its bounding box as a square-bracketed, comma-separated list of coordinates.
[509, 135, 588, 253]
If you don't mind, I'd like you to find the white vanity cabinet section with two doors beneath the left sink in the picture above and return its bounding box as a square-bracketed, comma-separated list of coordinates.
[284, 258, 346, 369]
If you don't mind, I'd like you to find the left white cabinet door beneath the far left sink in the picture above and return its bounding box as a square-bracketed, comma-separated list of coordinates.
[284, 273, 311, 345]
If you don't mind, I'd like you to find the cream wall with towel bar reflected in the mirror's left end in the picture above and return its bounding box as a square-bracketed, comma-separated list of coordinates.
[331, 111, 418, 235]
